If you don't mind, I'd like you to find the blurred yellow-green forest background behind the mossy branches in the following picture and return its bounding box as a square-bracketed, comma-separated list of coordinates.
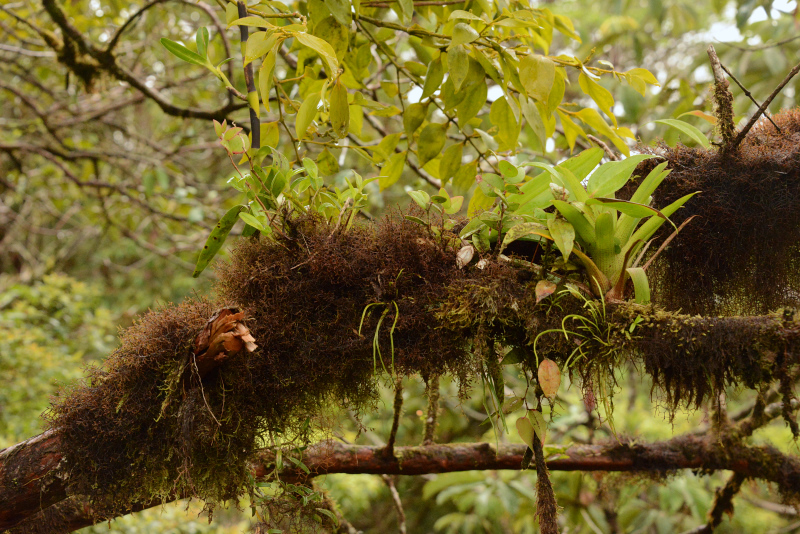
[0, 0, 800, 533]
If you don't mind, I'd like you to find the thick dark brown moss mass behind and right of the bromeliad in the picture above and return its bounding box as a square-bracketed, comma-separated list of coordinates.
[626, 110, 800, 315]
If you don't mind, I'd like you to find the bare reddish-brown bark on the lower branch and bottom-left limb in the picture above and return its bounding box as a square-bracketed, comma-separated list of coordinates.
[0, 435, 800, 534]
